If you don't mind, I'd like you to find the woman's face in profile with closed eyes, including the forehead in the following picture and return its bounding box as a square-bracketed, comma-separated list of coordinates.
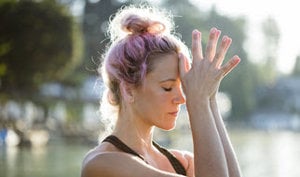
[133, 53, 185, 130]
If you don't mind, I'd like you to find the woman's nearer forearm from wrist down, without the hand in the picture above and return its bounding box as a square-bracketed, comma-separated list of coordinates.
[187, 99, 228, 177]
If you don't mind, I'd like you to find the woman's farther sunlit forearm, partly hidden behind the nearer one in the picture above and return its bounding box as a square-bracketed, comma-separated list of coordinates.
[210, 98, 241, 177]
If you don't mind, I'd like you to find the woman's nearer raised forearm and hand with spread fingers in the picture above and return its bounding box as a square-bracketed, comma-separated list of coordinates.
[179, 28, 240, 177]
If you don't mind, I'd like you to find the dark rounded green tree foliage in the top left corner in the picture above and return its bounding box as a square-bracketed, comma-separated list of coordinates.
[0, 0, 80, 95]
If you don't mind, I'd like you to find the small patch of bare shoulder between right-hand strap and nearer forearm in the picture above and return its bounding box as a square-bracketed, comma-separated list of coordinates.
[170, 149, 194, 176]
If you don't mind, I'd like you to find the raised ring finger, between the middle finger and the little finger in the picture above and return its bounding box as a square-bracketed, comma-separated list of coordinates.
[214, 36, 232, 68]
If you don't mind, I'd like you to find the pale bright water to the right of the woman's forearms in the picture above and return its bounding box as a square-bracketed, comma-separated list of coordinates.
[231, 131, 300, 177]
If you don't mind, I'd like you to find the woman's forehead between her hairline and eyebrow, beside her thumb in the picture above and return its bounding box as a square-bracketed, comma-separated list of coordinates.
[147, 53, 178, 81]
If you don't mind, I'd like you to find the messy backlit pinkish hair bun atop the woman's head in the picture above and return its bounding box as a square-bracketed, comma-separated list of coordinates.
[109, 6, 173, 40]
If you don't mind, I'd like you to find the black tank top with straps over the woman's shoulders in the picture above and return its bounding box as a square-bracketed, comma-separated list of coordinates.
[102, 135, 186, 176]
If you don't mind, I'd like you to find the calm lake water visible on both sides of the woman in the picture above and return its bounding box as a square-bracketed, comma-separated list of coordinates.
[0, 130, 300, 177]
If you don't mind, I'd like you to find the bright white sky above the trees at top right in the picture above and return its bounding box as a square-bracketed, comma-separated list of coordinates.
[192, 0, 300, 74]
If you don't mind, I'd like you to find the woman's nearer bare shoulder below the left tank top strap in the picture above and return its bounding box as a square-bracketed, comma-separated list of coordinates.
[81, 145, 180, 177]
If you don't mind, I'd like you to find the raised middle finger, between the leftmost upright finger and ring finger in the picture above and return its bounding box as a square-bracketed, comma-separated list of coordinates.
[205, 28, 221, 61]
